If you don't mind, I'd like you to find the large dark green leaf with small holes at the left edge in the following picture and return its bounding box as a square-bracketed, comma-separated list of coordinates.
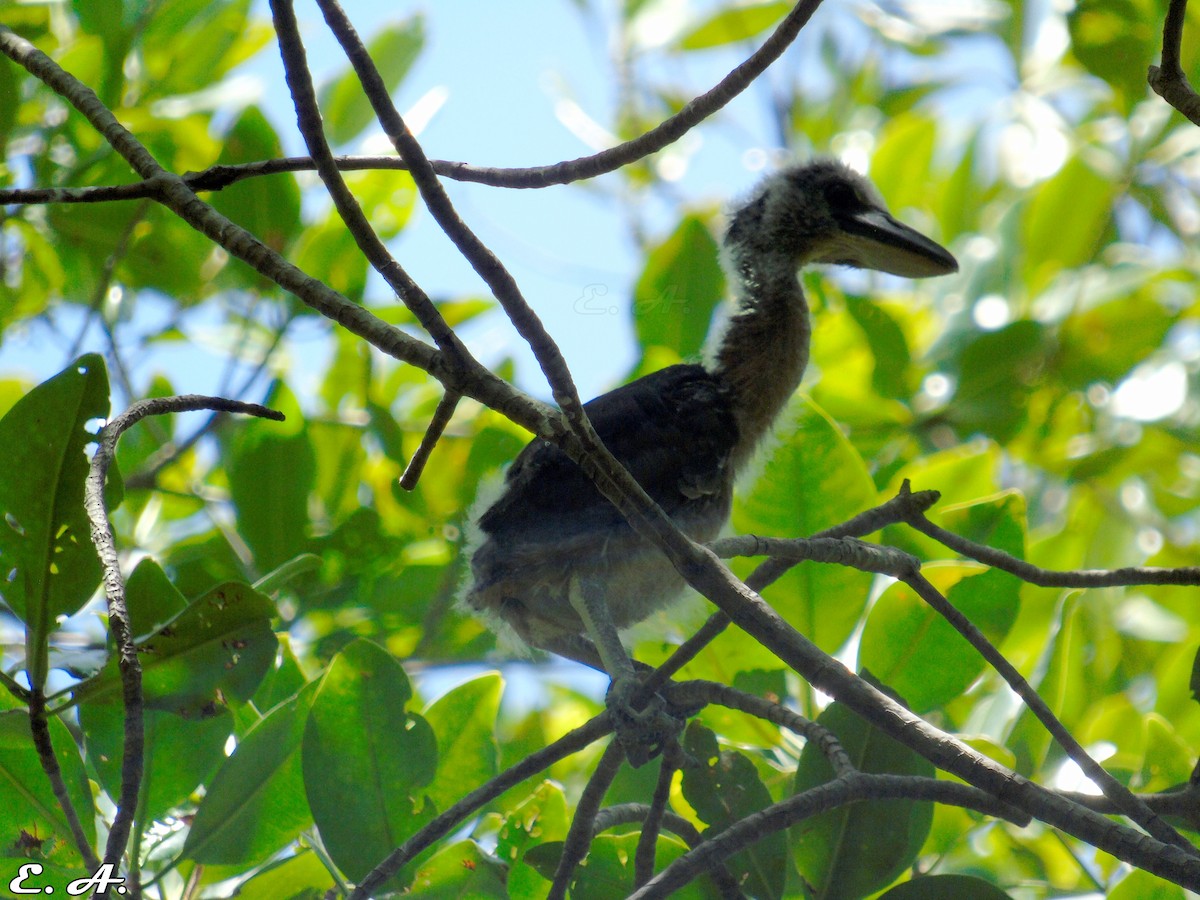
[0, 354, 108, 686]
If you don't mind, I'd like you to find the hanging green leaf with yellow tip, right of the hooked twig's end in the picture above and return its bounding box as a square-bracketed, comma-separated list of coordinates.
[226, 384, 317, 572]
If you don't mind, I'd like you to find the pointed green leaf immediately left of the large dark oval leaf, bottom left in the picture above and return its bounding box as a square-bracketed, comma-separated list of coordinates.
[182, 686, 316, 865]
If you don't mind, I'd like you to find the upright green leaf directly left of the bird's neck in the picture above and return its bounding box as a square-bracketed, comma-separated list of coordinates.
[634, 215, 725, 359]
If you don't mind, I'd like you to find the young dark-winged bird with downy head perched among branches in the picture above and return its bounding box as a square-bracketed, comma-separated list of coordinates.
[462, 158, 958, 724]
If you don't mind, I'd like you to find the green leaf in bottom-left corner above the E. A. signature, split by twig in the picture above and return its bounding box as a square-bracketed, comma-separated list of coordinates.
[0, 698, 96, 868]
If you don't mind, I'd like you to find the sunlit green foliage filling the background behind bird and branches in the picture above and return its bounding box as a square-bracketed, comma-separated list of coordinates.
[0, 0, 1200, 898]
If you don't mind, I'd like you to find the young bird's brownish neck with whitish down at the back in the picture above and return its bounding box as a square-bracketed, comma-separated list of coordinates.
[713, 253, 811, 468]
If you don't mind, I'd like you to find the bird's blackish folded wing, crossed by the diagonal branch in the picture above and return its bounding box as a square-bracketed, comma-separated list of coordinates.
[479, 365, 738, 541]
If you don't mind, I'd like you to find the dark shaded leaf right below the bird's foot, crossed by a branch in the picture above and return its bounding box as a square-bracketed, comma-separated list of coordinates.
[682, 720, 787, 898]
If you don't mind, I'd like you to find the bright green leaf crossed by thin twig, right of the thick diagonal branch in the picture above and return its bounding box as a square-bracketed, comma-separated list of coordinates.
[858, 563, 1020, 713]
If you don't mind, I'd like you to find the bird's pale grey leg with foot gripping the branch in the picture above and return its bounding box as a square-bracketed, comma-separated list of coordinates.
[569, 576, 682, 768]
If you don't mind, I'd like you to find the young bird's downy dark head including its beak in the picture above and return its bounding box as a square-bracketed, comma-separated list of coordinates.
[725, 160, 959, 278]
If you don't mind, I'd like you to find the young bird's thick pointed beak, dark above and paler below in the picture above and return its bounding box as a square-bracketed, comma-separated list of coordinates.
[822, 206, 959, 278]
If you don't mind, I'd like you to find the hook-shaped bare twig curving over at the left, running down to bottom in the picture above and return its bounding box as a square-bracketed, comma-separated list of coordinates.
[84, 395, 283, 883]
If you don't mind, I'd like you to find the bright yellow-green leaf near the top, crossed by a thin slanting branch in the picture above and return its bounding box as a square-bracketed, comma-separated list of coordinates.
[317, 16, 425, 145]
